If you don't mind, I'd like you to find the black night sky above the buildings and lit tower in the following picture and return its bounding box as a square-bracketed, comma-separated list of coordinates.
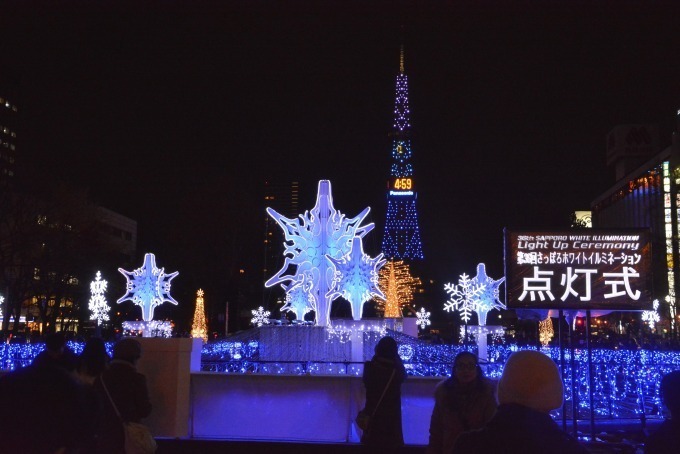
[0, 0, 680, 326]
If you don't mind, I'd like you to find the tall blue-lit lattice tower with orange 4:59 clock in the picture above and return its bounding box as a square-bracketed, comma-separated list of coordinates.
[382, 46, 423, 260]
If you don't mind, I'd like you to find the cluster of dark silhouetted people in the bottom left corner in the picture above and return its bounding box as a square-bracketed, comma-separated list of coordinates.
[0, 333, 151, 454]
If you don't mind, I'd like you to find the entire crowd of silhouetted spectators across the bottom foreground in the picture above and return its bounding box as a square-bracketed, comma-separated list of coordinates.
[0, 333, 680, 454]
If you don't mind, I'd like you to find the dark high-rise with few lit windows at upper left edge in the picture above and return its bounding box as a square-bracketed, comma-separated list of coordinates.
[0, 75, 19, 186]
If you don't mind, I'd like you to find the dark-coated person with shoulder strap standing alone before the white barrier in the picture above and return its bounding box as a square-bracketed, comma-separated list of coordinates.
[361, 336, 406, 452]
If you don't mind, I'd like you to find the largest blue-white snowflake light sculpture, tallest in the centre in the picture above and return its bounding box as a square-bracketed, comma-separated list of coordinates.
[265, 180, 374, 326]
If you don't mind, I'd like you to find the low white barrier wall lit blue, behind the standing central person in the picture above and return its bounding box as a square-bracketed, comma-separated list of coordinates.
[190, 372, 441, 445]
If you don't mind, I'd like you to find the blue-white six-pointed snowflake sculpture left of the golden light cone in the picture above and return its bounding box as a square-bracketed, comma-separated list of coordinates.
[117, 254, 179, 322]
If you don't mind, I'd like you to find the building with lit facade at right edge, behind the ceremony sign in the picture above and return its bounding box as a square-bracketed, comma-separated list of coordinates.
[591, 117, 680, 333]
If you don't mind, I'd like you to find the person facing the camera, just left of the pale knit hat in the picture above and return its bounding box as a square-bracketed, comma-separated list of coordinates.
[427, 352, 497, 454]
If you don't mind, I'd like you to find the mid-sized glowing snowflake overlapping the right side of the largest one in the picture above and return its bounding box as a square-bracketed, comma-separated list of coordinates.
[328, 237, 385, 320]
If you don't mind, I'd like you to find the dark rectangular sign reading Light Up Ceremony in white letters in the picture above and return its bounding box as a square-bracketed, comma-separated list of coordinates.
[505, 229, 652, 310]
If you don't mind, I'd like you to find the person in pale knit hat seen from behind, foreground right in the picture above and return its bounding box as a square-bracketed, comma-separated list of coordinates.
[451, 350, 588, 454]
